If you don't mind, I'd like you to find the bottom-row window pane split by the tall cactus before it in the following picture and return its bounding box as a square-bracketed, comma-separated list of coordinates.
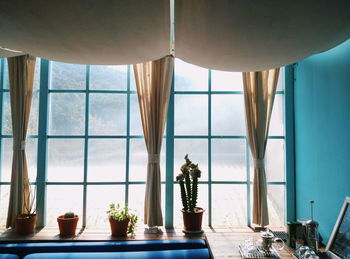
[174, 184, 209, 227]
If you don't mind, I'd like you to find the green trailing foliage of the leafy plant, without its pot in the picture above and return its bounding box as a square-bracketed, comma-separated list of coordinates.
[107, 203, 137, 236]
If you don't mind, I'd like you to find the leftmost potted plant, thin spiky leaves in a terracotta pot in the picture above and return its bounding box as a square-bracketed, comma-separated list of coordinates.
[15, 185, 37, 235]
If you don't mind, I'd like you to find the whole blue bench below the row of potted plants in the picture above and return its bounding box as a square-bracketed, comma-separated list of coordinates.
[0, 239, 210, 259]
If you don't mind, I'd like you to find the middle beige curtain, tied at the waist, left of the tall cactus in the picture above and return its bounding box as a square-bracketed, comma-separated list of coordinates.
[134, 56, 174, 227]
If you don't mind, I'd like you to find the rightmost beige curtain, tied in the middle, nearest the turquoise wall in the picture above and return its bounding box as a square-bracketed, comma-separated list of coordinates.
[243, 68, 279, 227]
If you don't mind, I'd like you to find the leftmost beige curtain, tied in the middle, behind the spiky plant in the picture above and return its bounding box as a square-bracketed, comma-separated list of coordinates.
[6, 55, 35, 228]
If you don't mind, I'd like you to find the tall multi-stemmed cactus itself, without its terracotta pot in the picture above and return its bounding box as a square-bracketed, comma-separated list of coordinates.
[176, 154, 201, 212]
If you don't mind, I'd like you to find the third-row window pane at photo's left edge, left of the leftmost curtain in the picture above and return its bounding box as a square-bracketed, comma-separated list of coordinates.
[0, 138, 13, 182]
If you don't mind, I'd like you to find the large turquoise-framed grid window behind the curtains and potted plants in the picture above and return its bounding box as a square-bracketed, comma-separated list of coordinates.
[0, 59, 286, 230]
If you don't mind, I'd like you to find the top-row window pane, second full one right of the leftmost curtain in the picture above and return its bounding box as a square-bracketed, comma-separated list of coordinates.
[90, 66, 128, 90]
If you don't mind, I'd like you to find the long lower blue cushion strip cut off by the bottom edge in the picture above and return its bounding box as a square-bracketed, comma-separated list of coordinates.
[24, 248, 211, 259]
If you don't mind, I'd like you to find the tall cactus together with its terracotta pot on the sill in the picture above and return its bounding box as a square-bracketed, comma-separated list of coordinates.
[176, 155, 204, 233]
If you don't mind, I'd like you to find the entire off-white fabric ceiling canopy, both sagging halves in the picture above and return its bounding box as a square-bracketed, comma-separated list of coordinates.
[0, 0, 350, 71]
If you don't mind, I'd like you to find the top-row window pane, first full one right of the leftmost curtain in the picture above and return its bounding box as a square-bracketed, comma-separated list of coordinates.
[51, 62, 86, 90]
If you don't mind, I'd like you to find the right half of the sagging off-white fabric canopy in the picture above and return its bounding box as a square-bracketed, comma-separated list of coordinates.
[175, 0, 350, 71]
